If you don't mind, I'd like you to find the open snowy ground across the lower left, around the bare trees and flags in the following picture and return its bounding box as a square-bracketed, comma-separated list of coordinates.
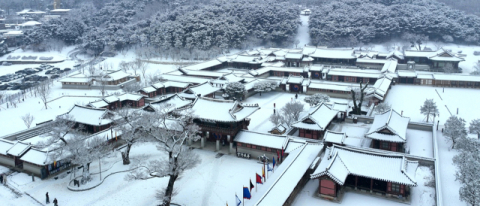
[0, 145, 262, 206]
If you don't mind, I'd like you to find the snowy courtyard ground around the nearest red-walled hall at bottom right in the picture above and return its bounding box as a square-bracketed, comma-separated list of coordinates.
[292, 166, 436, 206]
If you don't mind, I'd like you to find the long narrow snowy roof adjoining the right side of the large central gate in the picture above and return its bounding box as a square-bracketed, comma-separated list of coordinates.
[234, 130, 288, 149]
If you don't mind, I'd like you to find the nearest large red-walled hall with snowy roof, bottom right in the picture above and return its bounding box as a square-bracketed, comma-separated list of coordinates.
[310, 145, 418, 201]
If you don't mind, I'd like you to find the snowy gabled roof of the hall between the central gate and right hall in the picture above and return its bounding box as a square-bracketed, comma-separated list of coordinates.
[292, 103, 338, 131]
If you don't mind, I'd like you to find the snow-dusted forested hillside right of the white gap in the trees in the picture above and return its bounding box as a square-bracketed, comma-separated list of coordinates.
[309, 0, 480, 46]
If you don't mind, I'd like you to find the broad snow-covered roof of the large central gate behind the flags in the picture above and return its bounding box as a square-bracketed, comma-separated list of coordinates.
[192, 97, 260, 122]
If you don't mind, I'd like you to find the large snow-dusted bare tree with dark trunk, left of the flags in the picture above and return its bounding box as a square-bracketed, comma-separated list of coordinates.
[128, 110, 200, 206]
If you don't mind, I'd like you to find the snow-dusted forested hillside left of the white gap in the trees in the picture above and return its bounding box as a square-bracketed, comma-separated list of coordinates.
[26, 0, 299, 55]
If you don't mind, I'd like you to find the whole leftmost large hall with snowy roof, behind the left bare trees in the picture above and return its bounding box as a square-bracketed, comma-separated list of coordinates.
[58, 105, 113, 133]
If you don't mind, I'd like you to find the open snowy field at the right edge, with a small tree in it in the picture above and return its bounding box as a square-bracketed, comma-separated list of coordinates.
[386, 85, 480, 127]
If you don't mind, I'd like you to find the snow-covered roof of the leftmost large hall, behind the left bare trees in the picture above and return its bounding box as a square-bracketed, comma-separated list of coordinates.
[59, 105, 112, 126]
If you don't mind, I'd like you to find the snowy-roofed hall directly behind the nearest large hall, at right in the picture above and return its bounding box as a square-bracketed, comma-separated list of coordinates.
[365, 110, 410, 152]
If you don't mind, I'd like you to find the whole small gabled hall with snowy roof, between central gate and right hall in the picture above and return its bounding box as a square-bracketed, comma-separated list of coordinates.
[292, 103, 338, 139]
